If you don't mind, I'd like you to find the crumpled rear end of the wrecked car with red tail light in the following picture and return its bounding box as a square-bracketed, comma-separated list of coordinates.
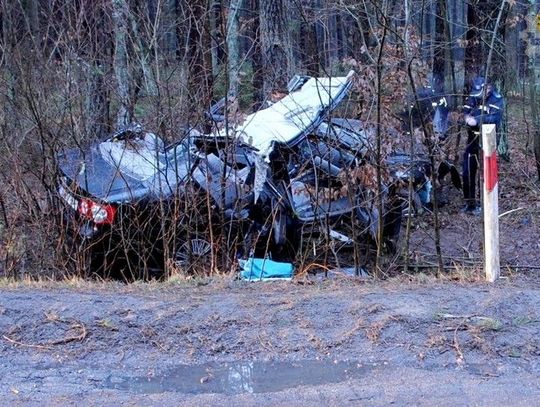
[58, 127, 260, 278]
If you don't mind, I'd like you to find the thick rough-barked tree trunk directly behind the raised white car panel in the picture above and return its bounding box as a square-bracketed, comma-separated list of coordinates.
[259, 0, 292, 96]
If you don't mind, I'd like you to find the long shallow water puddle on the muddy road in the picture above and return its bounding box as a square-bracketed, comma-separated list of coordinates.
[105, 360, 382, 394]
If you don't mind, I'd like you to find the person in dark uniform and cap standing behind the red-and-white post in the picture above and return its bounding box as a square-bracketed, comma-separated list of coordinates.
[462, 77, 504, 215]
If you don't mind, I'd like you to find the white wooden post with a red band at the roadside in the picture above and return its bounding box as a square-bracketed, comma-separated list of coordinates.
[482, 124, 501, 283]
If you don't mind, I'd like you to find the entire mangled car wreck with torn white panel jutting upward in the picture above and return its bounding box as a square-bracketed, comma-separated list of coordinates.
[58, 72, 440, 275]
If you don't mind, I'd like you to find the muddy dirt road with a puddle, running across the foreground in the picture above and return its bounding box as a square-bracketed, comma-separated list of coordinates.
[0, 277, 540, 406]
